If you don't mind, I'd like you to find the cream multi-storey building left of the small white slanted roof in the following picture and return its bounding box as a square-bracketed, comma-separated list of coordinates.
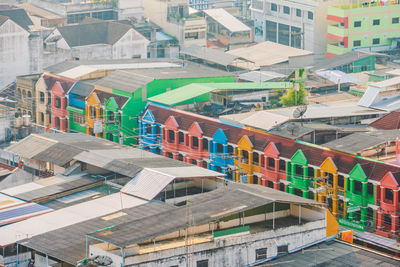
[143, 0, 207, 47]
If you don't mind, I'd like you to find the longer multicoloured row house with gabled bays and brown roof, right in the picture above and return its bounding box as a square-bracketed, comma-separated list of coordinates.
[139, 104, 400, 242]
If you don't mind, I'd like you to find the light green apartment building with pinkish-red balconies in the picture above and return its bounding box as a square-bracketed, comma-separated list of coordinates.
[326, 1, 400, 57]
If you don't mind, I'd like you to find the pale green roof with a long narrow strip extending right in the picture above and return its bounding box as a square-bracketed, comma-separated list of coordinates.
[148, 82, 292, 106]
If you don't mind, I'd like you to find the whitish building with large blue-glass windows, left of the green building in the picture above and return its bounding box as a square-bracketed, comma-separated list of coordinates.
[250, 0, 337, 54]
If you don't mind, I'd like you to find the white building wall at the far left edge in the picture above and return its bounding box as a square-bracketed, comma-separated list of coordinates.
[0, 19, 31, 88]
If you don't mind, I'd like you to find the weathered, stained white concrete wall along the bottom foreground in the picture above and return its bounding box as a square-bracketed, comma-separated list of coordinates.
[124, 220, 325, 267]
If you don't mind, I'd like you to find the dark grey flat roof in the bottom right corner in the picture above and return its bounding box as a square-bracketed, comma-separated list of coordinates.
[265, 240, 399, 267]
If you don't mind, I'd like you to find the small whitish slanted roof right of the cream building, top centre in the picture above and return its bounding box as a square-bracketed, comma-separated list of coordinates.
[203, 8, 251, 33]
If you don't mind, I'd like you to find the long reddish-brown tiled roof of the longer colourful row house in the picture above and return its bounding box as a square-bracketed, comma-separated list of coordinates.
[148, 105, 400, 181]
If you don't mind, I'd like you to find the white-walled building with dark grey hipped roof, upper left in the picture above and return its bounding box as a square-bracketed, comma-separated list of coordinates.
[43, 19, 149, 66]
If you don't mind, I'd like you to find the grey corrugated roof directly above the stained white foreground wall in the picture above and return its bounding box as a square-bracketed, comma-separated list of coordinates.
[92, 184, 324, 246]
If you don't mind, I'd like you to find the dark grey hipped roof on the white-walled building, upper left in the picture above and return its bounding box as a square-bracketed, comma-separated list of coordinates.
[57, 21, 132, 47]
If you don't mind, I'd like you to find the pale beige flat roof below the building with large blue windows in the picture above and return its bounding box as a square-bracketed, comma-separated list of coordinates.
[227, 41, 312, 69]
